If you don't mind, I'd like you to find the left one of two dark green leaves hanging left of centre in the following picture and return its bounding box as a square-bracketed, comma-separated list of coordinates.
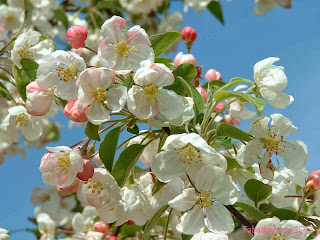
[99, 127, 121, 172]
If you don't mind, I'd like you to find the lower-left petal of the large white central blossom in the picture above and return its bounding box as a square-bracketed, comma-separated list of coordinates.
[151, 151, 185, 182]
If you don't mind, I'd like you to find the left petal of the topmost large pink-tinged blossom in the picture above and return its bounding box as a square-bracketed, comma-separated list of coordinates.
[98, 40, 118, 70]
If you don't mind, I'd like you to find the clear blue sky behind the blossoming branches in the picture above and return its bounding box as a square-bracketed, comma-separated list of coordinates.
[0, 0, 320, 240]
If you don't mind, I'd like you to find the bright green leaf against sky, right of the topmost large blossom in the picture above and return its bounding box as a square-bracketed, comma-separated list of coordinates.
[150, 32, 182, 57]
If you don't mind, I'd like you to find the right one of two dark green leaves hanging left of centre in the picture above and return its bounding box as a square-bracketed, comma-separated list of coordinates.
[111, 144, 145, 187]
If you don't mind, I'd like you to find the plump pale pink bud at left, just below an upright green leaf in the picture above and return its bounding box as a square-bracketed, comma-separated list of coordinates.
[26, 81, 53, 116]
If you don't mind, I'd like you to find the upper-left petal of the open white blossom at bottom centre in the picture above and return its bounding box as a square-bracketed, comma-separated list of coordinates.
[168, 188, 197, 212]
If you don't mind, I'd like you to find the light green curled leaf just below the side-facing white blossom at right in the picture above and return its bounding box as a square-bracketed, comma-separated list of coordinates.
[213, 90, 266, 116]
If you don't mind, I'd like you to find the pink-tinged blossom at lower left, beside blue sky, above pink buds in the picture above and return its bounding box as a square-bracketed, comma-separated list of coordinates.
[40, 146, 83, 188]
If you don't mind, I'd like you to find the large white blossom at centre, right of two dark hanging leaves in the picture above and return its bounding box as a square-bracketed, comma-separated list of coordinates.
[151, 133, 227, 182]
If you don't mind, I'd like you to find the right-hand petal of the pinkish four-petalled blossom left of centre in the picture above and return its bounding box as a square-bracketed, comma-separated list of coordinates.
[106, 85, 127, 112]
